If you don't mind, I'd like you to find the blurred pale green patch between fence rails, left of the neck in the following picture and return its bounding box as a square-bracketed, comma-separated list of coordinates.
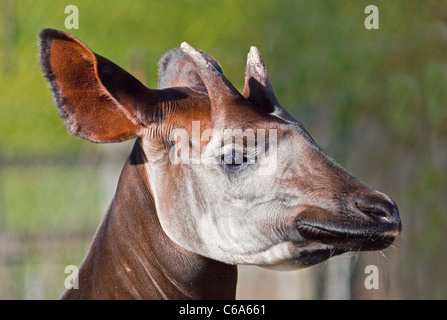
[1, 166, 103, 234]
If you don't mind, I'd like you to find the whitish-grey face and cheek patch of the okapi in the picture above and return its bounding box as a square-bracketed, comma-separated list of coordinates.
[143, 117, 397, 268]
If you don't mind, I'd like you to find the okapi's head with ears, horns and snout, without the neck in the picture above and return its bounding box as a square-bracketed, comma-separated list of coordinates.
[40, 29, 401, 269]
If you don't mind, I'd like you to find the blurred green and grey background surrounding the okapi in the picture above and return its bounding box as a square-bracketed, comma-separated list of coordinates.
[0, 0, 447, 299]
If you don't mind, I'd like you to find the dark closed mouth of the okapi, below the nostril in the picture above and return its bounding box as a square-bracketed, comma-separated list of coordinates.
[297, 221, 399, 251]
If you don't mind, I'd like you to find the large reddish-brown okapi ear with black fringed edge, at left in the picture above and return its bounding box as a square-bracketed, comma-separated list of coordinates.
[39, 29, 151, 143]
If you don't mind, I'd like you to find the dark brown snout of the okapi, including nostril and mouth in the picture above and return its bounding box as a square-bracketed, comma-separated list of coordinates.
[296, 189, 402, 254]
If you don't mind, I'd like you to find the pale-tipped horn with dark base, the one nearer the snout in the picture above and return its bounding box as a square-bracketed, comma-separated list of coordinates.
[242, 47, 296, 123]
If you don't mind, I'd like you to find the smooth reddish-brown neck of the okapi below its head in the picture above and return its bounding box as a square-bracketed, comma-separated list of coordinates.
[61, 140, 242, 299]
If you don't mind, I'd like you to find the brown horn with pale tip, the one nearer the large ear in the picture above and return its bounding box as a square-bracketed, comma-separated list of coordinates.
[180, 42, 240, 104]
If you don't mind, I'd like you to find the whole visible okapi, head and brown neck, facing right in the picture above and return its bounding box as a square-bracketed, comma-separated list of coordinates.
[39, 29, 401, 299]
